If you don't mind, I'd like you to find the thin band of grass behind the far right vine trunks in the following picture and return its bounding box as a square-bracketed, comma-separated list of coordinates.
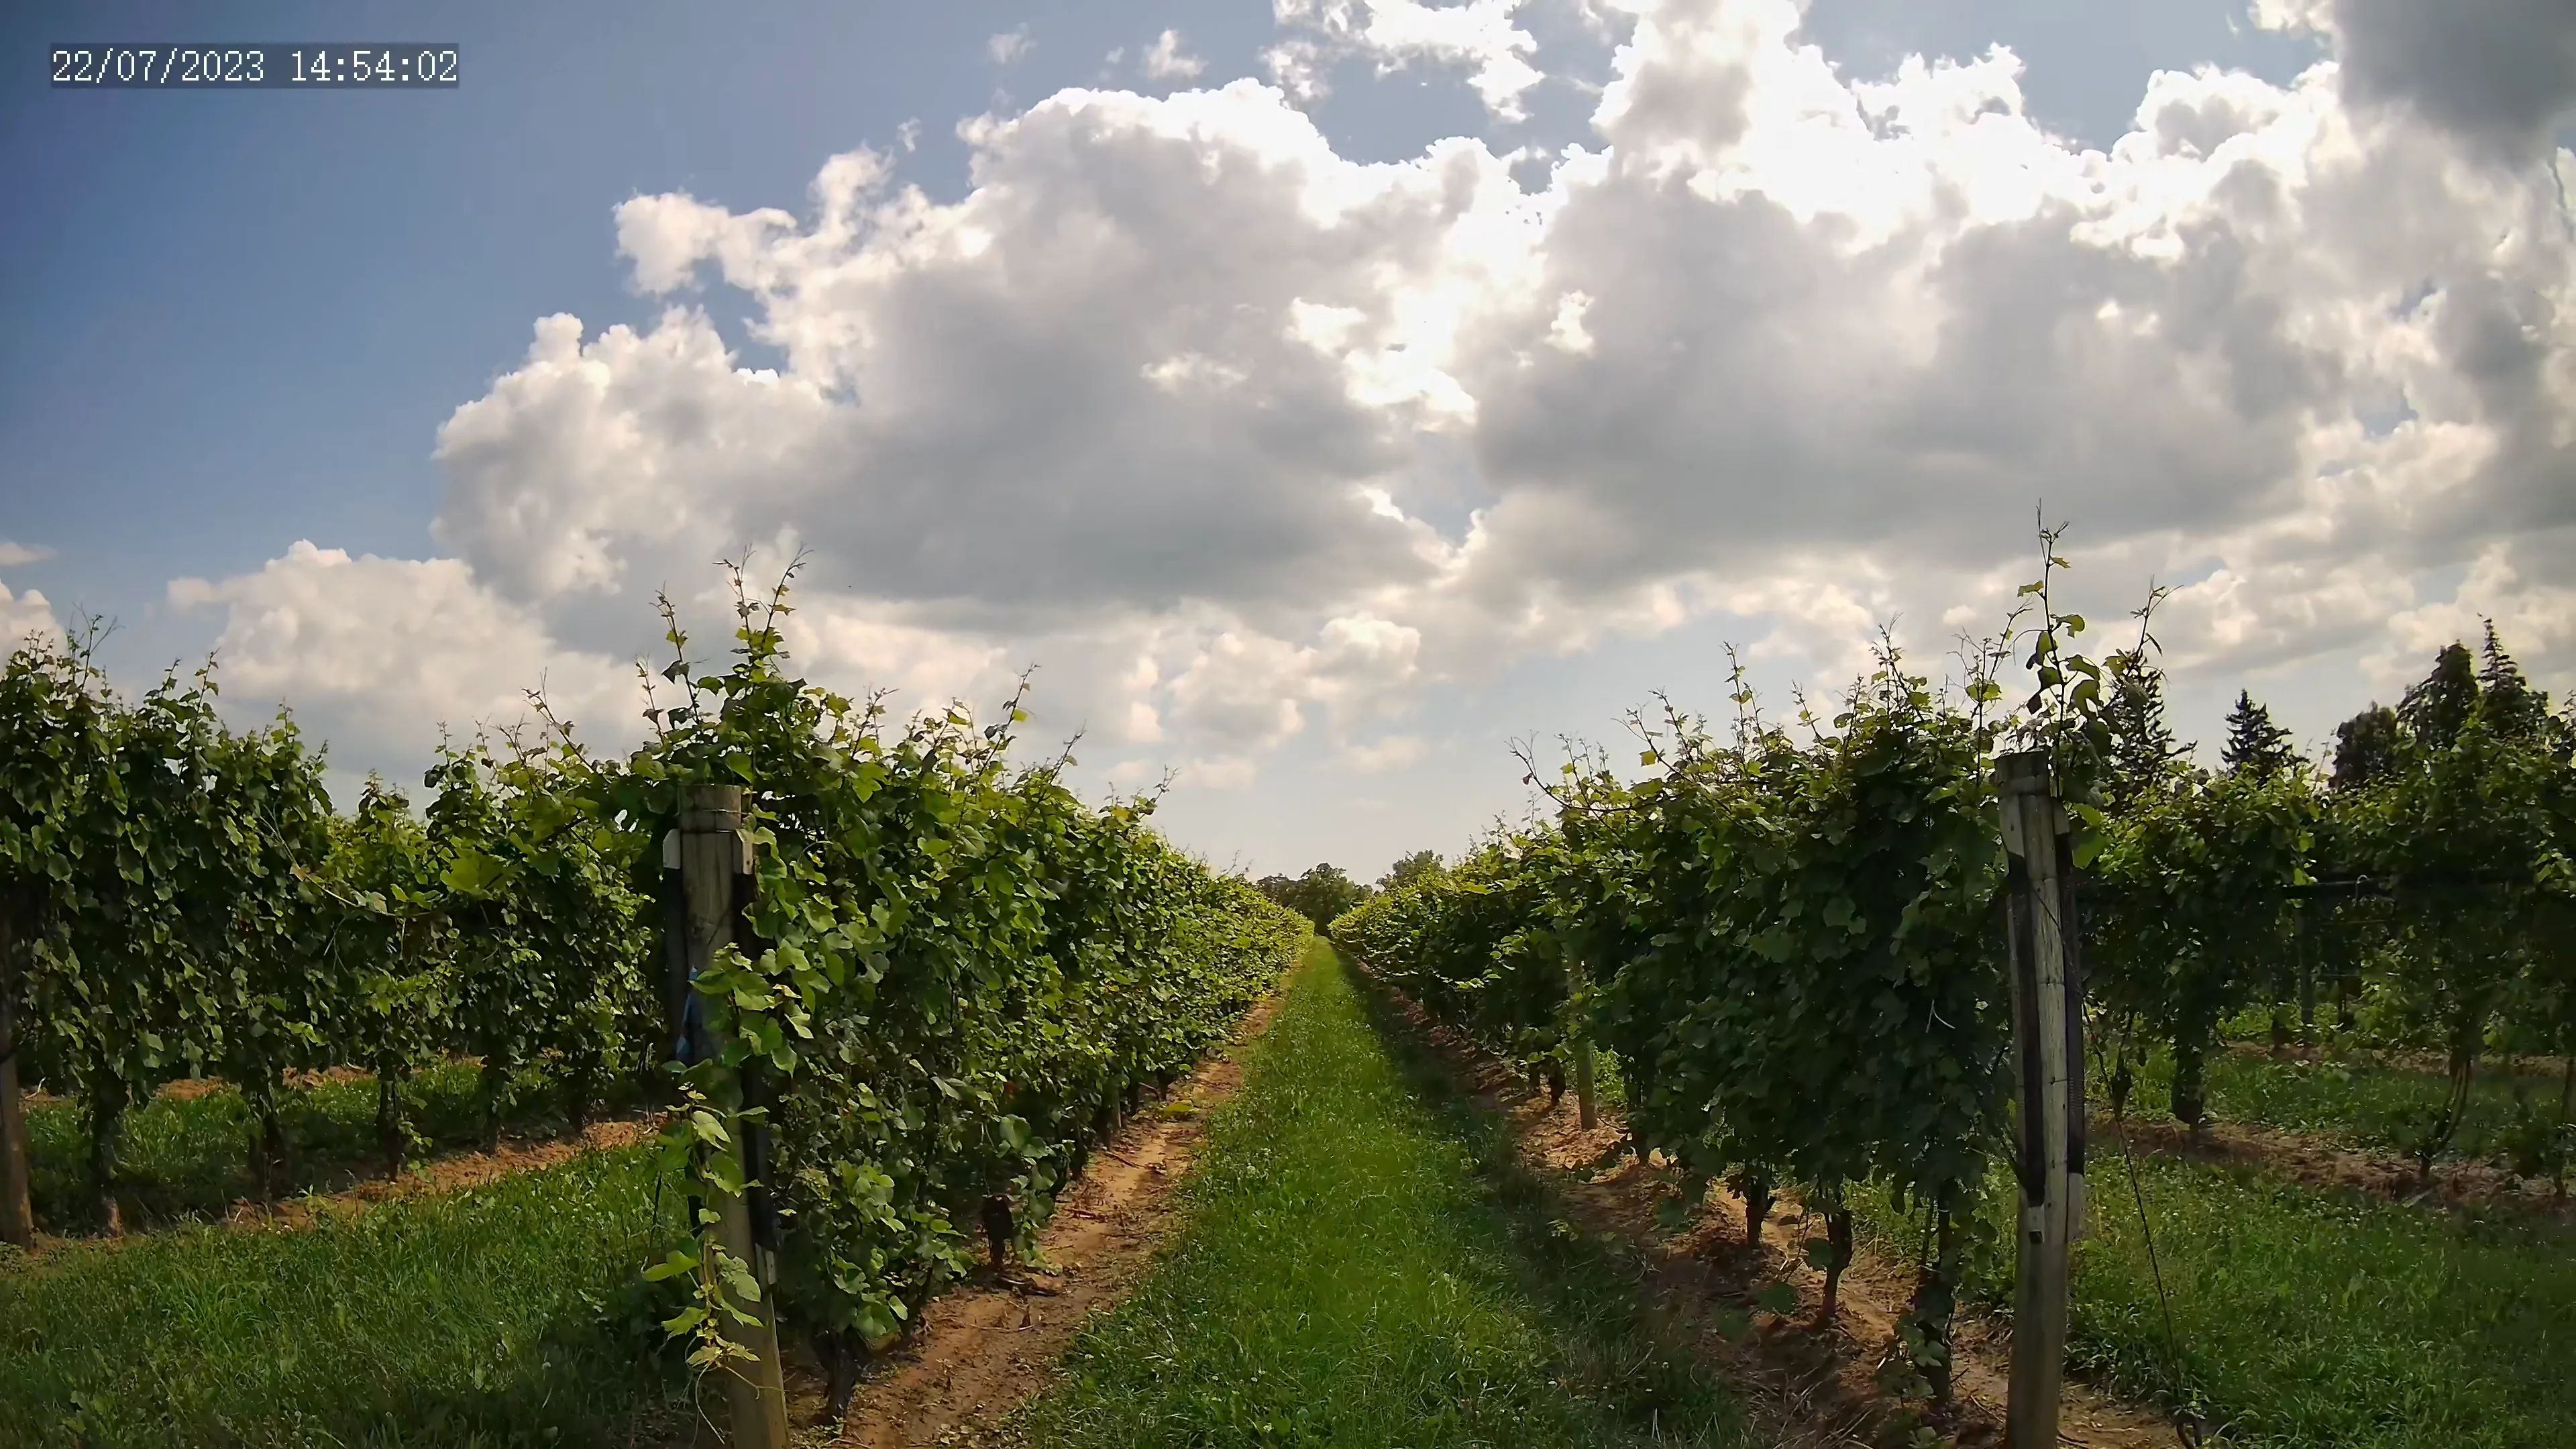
[2094, 1036, 2558, 1165]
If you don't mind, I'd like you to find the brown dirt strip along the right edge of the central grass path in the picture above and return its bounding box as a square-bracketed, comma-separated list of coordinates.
[1376, 964, 2177, 1449]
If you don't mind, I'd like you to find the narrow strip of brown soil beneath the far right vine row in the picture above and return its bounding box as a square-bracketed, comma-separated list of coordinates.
[2092, 1116, 2576, 1220]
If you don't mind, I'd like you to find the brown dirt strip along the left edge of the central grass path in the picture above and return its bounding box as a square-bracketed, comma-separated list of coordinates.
[829, 998, 1278, 1449]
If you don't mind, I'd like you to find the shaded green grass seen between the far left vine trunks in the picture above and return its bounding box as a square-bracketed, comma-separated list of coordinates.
[28, 1062, 649, 1232]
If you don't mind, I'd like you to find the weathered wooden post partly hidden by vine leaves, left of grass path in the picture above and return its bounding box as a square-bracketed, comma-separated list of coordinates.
[665, 784, 788, 1449]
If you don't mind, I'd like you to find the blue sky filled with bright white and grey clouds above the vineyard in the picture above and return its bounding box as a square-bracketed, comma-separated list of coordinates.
[0, 0, 2576, 871]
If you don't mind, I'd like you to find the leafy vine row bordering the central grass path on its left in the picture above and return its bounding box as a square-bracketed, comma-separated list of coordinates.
[602, 572, 1311, 1395]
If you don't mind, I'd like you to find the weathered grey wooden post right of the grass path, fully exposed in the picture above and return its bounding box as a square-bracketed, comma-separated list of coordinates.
[1996, 750, 2084, 1449]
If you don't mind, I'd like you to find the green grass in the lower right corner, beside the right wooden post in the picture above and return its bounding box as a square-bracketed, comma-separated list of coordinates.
[1862, 1142, 2576, 1449]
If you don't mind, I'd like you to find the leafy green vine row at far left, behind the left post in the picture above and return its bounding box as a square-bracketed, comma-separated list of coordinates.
[0, 639, 659, 1222]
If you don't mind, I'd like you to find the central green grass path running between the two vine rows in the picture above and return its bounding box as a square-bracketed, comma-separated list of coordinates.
[1015, 947, 1747, 1449]
